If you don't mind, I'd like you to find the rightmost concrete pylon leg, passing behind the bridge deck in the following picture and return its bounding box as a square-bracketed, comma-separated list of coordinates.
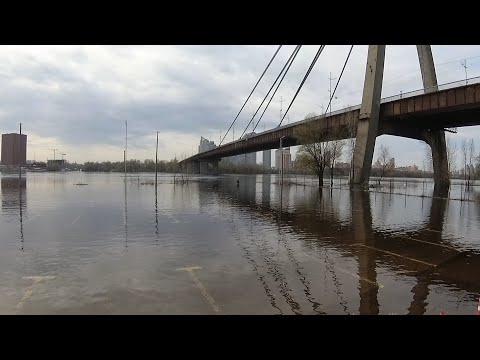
[417, 45, 450, 197]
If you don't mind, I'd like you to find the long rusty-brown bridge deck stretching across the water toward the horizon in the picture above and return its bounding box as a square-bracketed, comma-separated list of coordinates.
[181, 77, 480, 162]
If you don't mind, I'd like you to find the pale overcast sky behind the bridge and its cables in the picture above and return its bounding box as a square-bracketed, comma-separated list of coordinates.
[0, 45, 480, 166]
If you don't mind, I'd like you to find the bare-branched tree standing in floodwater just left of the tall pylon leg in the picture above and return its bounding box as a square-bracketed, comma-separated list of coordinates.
[295, 113, 331, 187]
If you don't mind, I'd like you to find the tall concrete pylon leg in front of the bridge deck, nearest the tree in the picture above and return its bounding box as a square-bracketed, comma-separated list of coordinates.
[353, 45, 385, 185]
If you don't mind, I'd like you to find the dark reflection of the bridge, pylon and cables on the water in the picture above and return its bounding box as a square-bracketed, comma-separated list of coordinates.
[199, 176, 480, 314]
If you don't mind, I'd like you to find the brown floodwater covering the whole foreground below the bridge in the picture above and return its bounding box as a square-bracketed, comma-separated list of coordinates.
[0, 172, 480, 315]
